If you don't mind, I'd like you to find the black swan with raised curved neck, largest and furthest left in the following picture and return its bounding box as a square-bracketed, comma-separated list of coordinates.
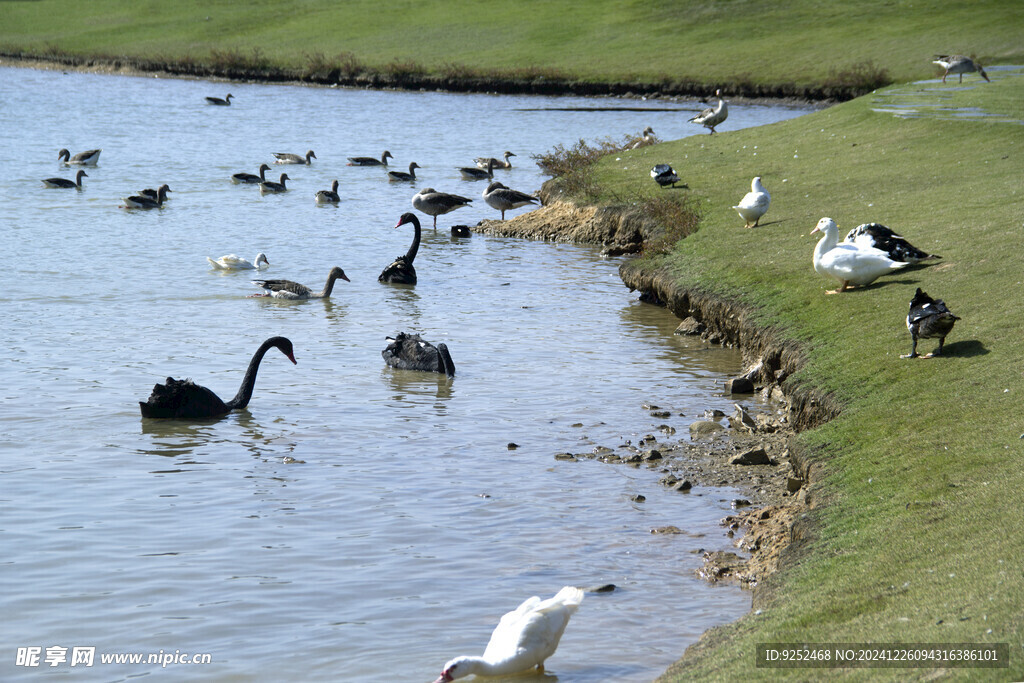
[138, 337, 295, 418]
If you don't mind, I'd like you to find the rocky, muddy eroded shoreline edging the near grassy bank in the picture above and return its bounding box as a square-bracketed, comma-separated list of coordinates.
[473, 196, 840, 604]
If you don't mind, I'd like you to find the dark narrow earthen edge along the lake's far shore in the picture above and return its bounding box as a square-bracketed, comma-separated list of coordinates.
[0, 51, 847, 104]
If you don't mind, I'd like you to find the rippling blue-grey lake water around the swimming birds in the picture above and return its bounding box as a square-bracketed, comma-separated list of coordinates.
[0, 62, 815, 682]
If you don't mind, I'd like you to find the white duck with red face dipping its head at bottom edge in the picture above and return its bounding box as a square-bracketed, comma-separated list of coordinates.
[434, 586, 584, 683]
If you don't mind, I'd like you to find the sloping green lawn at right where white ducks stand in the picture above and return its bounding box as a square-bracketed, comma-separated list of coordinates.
[577, 70, 1024, 680]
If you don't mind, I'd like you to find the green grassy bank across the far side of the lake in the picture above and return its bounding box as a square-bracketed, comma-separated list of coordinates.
[0, 0, 1024, 95]
